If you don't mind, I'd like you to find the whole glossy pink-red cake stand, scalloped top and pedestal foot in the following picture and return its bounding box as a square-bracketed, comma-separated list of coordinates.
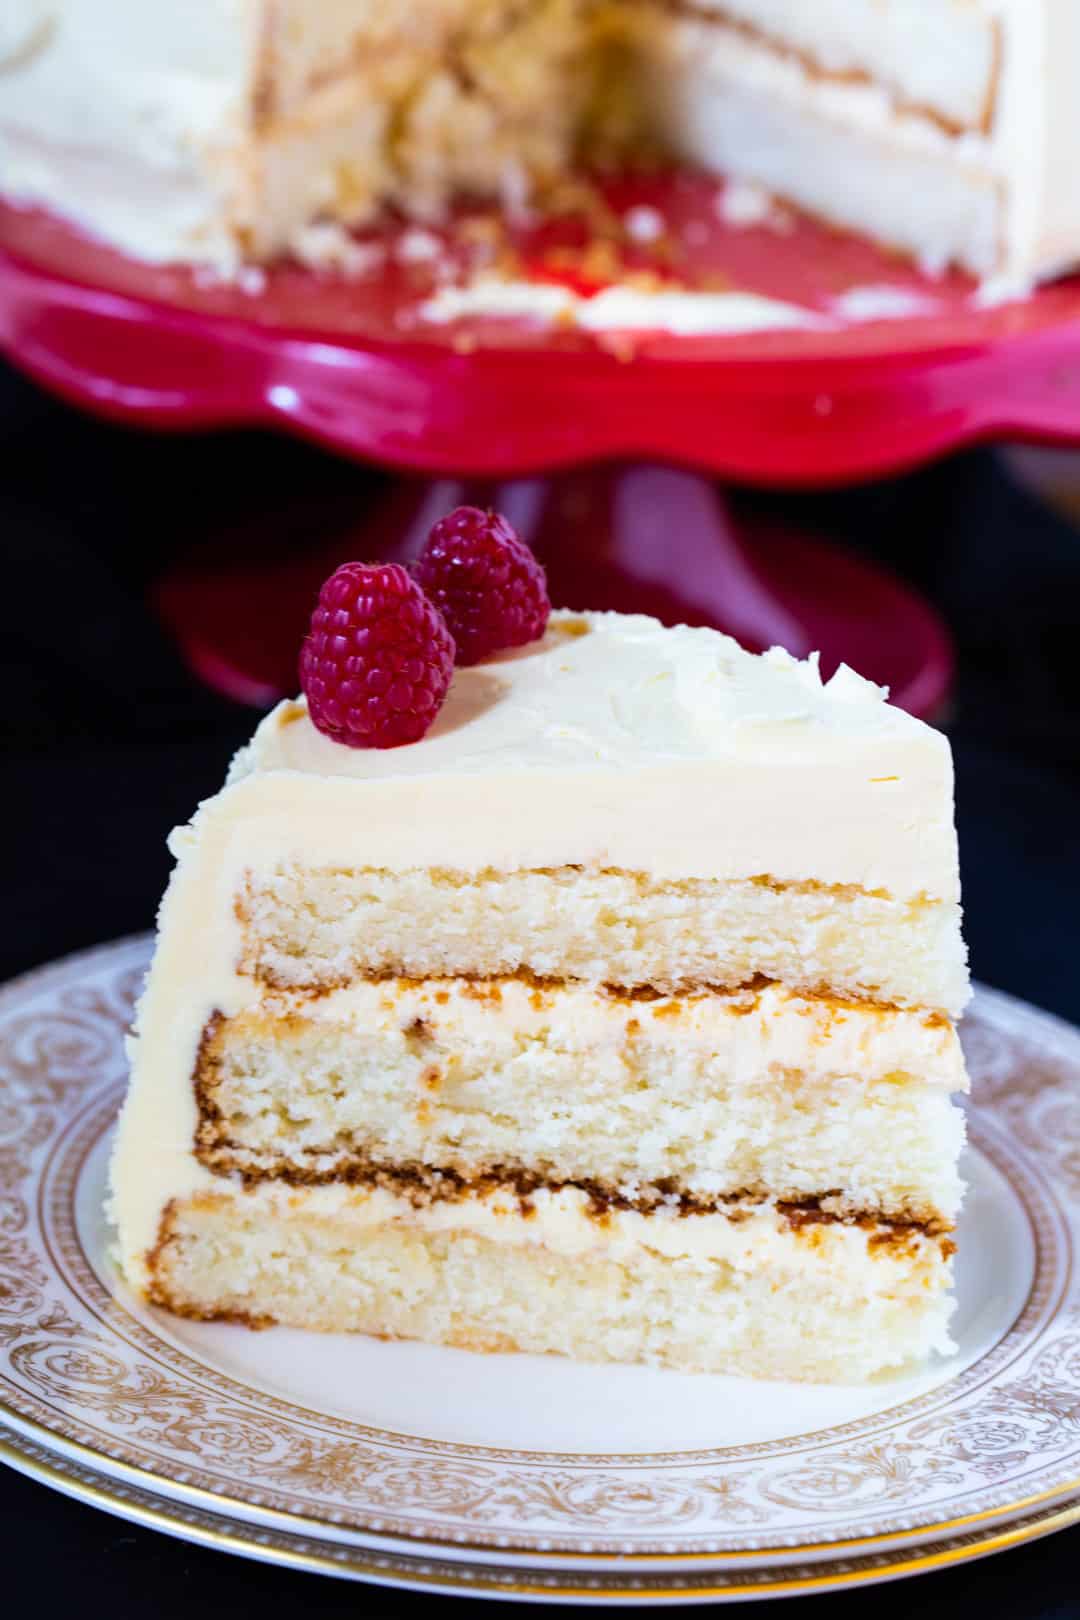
[0, 173, 1080, 713]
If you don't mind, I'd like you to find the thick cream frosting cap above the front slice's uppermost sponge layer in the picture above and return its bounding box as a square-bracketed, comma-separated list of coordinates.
[220, 614, 959, 901]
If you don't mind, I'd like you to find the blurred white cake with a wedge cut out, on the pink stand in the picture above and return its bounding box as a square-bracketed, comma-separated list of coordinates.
[0, 0, 1080, 279]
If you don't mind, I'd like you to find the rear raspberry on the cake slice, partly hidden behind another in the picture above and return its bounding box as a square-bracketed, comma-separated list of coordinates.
[413, 507, 551, 664]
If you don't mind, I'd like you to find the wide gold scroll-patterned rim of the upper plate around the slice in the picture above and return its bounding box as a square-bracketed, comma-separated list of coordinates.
[0, 938, 1080, 1565]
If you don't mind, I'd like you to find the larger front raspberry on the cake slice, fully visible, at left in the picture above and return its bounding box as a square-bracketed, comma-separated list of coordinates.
[300, 562, 453, 748]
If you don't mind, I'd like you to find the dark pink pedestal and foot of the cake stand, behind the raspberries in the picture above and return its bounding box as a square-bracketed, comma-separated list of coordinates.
[155, 463, 952, 716]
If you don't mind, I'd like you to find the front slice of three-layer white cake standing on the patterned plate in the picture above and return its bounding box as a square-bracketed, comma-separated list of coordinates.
[113, 541, 968, 1380]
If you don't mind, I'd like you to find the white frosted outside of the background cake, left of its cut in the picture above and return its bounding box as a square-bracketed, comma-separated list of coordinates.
[0, 0, 261, 266]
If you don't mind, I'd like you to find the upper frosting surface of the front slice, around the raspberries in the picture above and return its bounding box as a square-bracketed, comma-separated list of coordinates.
[235, 612, 925, 778]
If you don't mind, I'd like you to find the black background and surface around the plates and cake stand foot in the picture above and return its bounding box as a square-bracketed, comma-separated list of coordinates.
[0, 369, 1080, 1620]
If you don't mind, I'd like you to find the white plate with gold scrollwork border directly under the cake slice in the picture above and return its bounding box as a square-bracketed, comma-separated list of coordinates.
[0, 940, 1080, 1601]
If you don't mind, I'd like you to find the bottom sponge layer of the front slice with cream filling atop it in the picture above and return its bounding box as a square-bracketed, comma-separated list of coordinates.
[151, 1187, 950, 1382]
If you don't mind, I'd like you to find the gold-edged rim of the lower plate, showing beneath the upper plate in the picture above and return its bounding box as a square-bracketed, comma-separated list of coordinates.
[0, 1435, 1080, 1607]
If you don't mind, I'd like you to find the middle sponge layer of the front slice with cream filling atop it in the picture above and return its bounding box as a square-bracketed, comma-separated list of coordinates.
[198, 980, 967, 1226]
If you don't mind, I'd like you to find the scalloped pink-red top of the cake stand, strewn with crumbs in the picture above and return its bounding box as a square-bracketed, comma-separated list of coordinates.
[0, 172, 1080, 484]
